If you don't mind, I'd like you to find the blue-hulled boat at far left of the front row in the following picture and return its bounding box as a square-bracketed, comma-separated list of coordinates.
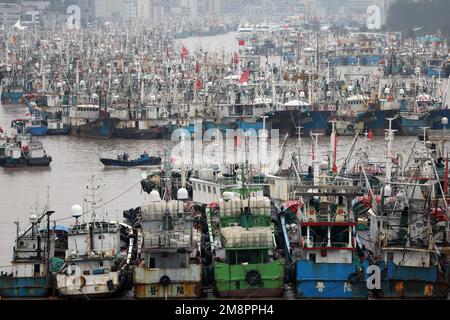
[0, 211, 56, 298]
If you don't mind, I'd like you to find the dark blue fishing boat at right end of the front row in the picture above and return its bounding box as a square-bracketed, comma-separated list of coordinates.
[365, 183, 449, 299]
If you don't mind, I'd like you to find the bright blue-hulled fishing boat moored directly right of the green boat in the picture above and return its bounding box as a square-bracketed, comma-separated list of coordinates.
[283, 169, 368, 299]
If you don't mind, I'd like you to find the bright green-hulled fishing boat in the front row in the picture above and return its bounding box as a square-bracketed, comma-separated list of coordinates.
[206, 166, 285, 298]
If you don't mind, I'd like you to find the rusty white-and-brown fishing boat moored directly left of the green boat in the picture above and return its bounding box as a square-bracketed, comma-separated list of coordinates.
[127, 156, 204, 299]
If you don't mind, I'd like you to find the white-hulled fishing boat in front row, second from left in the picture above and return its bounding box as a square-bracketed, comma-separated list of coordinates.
[56, 181, 134, 299]
